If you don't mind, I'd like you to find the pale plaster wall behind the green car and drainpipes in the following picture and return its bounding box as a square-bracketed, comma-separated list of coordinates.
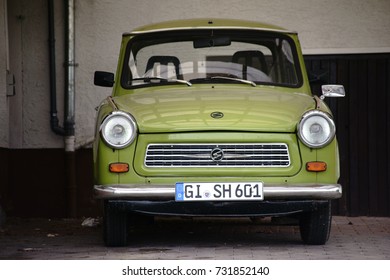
[0, 0, 390, 148]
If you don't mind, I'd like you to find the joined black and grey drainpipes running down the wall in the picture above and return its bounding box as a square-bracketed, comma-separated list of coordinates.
[48, 0, 77, 218]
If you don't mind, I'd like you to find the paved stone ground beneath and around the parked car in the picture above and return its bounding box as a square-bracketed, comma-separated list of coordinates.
[0, 216, 390, 260]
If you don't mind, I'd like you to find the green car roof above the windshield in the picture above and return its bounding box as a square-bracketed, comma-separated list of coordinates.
[123, 18, 296, 36]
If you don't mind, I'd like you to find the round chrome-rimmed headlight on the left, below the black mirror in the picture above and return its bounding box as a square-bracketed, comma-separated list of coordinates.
[100, 111, 137, 149]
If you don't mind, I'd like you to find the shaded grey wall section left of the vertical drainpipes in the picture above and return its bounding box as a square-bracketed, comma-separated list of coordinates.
[0, 0, 64, 149]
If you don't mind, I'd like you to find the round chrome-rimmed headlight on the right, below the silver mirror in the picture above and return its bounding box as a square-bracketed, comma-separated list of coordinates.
[298, 110, 336, 148]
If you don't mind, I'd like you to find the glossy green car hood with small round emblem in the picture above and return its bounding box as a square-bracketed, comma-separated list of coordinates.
[114, 85, 315, 133]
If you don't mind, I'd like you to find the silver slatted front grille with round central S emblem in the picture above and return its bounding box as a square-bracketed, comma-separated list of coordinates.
[145, 143, 290, 167]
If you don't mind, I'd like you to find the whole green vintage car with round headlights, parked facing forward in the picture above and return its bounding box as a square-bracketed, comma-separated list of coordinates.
[94, 19, 344, 246]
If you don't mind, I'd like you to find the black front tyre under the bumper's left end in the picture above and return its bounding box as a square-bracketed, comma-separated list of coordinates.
[103, 202, 127, 247]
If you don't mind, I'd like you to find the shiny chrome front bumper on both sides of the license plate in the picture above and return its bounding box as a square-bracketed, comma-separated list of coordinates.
[94, 184, 342, 200]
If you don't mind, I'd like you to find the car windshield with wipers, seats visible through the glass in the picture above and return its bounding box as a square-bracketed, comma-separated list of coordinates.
[121, 30, 301, 88]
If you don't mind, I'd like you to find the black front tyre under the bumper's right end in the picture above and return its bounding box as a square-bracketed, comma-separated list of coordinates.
[299, 201, 332, 245]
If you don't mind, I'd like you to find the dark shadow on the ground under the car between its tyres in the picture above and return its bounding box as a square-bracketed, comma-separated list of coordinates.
[128, 217, 301, 248]
